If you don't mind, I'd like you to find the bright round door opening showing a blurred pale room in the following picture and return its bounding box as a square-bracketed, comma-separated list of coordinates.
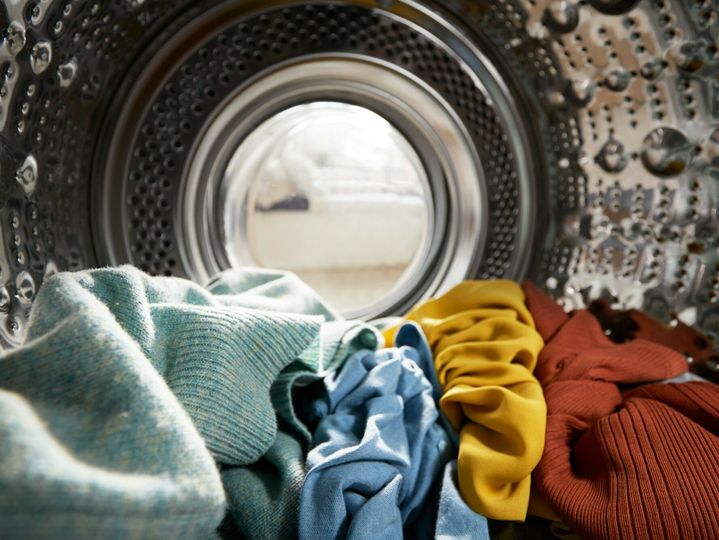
[221, 101, 434, 316]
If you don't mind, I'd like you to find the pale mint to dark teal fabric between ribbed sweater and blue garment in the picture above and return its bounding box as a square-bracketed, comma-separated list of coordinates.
[209, 268, 382, 540]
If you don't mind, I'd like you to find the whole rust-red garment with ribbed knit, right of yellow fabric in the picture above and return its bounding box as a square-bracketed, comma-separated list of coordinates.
[525, 284, 719, 539]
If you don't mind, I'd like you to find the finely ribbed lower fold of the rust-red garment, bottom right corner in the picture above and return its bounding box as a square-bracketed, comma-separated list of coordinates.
[535, 381, 719, 539]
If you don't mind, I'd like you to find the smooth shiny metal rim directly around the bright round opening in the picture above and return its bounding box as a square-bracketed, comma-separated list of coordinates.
[181, 55, 487, 318]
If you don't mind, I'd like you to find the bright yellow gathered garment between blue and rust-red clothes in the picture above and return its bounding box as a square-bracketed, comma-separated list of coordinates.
[385, 281, 547, 521]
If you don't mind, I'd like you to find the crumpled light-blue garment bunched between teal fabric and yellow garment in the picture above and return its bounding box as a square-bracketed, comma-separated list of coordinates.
[299, 324, 451, 539]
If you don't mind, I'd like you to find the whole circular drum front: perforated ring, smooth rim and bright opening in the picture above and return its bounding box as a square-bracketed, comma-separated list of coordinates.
[96, 0, 544, 318]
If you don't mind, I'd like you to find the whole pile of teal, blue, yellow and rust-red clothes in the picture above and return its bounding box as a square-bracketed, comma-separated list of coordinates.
[0, 267, 719, 540]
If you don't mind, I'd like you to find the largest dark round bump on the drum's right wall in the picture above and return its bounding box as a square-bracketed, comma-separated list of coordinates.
[642, 127, 694, 178]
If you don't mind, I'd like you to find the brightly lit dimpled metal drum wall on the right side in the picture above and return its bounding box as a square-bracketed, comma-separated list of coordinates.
[523, 1, 719, 340]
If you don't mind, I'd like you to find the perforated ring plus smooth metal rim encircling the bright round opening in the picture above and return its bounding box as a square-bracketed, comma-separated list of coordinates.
[100, 2, 536, 317]
